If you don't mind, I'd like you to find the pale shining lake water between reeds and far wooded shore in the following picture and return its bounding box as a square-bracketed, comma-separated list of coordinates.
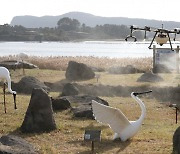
[0, 41, 179, 58]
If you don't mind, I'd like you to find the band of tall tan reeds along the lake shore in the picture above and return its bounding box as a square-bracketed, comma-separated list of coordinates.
[0, 56, 152, 70]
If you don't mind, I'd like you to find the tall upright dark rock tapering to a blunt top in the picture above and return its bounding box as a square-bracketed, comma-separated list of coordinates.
[21, 89, 56, 133]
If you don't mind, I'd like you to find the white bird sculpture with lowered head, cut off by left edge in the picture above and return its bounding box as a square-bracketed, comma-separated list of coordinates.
[0, 67, 17, 113]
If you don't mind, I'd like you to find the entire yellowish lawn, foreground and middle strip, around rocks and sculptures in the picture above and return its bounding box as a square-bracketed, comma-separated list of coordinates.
[0, 56, 180, 154]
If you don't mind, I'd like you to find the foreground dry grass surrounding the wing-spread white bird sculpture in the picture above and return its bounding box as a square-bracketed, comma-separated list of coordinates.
[0, 94, 178, 154]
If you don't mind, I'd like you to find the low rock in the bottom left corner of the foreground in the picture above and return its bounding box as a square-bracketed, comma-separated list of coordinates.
[0, 135, 38, 154]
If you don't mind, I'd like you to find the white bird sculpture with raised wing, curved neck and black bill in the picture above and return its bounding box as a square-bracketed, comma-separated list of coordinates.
[92, 91, 152, 141]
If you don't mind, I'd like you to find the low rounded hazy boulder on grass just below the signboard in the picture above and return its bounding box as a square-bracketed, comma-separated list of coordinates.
[137, 72, 163, 82]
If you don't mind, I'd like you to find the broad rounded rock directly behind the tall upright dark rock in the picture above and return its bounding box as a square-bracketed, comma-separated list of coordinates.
[13, 76, 50, 94]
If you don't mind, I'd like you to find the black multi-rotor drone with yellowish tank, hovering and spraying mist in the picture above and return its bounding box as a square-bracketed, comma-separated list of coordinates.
[125, 24, 180, 50]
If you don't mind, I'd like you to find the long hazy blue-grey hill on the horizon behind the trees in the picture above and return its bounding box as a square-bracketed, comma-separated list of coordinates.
[11, 12, 180, 29]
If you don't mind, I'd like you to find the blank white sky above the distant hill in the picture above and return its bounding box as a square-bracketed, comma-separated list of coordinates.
[0, 0, 180, 25]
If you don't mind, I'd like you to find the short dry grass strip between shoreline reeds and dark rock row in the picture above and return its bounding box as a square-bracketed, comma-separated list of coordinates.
[10, 69, 180, 87]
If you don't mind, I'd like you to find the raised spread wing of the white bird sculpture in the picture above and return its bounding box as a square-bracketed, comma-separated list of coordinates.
[92, 100, 130, 133]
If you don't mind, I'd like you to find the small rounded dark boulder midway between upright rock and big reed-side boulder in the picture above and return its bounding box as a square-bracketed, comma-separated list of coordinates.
[61, 83, 79, 96]
